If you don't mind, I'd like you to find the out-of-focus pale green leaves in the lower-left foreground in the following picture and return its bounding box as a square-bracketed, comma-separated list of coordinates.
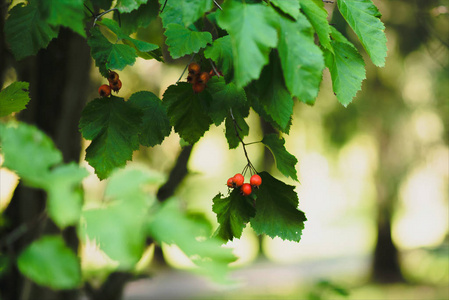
[0, 82, 235, 289]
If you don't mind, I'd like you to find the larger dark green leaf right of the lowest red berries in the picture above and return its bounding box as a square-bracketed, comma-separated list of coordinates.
[250, 172, 307, 242]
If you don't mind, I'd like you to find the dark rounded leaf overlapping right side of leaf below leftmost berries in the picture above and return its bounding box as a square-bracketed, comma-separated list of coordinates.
[128, 92, 171, 147]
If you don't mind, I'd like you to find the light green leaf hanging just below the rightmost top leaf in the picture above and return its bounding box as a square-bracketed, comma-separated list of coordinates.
[324, 27, 366, 107]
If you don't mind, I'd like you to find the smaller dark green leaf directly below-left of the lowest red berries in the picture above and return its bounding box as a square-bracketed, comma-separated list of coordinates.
[212, 188, 256, 241]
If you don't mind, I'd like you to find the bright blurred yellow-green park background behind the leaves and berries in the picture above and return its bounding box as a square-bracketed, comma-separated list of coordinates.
[1, 0, 449, 299]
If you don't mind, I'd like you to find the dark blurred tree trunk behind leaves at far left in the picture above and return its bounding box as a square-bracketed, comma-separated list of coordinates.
[0, 28, 91, 300]
